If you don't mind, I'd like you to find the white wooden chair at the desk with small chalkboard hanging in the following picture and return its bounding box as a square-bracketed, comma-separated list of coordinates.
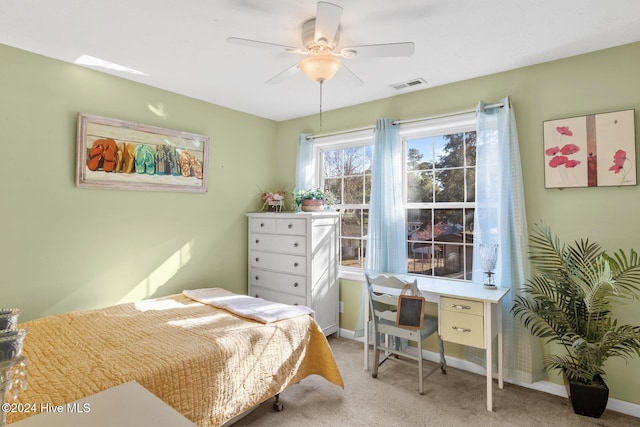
[366, 274, 447, 394]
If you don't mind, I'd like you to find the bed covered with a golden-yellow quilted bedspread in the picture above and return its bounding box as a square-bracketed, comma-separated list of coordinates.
[7, 294, 344, 427]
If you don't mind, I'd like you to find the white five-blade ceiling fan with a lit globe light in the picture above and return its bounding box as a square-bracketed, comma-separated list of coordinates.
[227, 1, 415, 84]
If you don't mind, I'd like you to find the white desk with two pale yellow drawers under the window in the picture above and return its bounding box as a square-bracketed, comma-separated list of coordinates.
[364, 276, 509, 411]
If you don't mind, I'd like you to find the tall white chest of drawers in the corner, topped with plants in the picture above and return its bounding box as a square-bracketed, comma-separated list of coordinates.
[247, 212, 340, 335]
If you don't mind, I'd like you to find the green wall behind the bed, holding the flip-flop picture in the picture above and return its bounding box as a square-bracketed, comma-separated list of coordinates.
[0, 45, 277, 321]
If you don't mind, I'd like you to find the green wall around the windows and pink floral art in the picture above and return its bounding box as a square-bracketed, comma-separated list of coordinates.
[278, 43, 640, 404]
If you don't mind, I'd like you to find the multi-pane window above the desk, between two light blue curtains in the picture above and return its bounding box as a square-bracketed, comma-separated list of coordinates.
[405, 131, 476, 280]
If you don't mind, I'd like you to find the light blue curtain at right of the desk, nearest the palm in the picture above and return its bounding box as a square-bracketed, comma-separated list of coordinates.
[472, 97, 546, 382]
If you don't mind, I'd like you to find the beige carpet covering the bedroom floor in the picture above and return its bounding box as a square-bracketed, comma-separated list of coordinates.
[234, 337, 640, 427]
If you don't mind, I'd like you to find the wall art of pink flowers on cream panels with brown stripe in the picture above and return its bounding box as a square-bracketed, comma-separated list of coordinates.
[544, 110, 636, 188]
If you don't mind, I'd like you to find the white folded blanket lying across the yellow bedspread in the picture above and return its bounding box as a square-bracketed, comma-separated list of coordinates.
[182, 288, 315, 323]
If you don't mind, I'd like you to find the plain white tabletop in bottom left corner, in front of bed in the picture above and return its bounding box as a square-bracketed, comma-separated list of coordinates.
[10, 381, 197, 427]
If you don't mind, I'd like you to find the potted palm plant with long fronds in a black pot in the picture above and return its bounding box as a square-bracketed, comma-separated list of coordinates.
[511, 224, 640, 418]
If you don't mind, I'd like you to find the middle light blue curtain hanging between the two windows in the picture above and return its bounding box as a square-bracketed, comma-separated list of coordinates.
[365, 119, 407, 274]
